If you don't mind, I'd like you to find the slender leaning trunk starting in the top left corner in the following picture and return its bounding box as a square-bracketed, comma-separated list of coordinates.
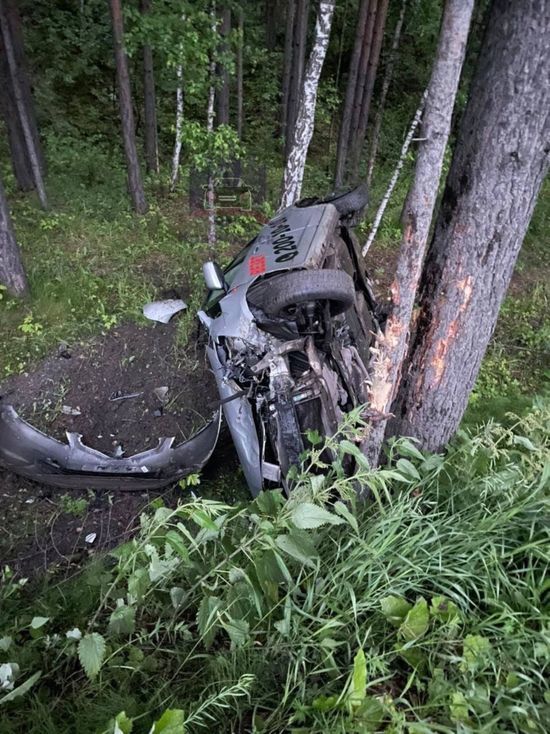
[0, 0, 48, 209]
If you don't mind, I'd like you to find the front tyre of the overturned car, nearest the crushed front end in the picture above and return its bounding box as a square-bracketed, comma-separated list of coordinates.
[250, 270, 355, 316]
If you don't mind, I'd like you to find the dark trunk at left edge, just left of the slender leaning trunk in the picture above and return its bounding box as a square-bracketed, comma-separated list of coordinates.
[0, 44, 35, 191]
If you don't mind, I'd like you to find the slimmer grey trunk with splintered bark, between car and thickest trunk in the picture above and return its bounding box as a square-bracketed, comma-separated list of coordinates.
[363, 0, 474, 466]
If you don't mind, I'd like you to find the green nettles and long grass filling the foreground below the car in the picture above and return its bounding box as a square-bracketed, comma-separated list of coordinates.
[0, 404, 550, 734]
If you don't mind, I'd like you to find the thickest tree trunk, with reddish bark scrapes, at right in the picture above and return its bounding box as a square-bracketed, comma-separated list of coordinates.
[393, 0, 550, 450]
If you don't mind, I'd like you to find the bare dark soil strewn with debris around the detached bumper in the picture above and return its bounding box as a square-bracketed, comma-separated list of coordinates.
[0, 317, 229, 576]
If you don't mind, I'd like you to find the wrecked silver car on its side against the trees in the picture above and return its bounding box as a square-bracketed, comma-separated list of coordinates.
[199, 187, 377, 494]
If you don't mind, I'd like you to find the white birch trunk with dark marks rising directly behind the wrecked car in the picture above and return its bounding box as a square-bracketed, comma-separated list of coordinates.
[280, 0, 334, 209]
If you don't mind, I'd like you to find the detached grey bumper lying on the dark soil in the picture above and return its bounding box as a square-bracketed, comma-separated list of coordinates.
[0, 405, 221, 490]
